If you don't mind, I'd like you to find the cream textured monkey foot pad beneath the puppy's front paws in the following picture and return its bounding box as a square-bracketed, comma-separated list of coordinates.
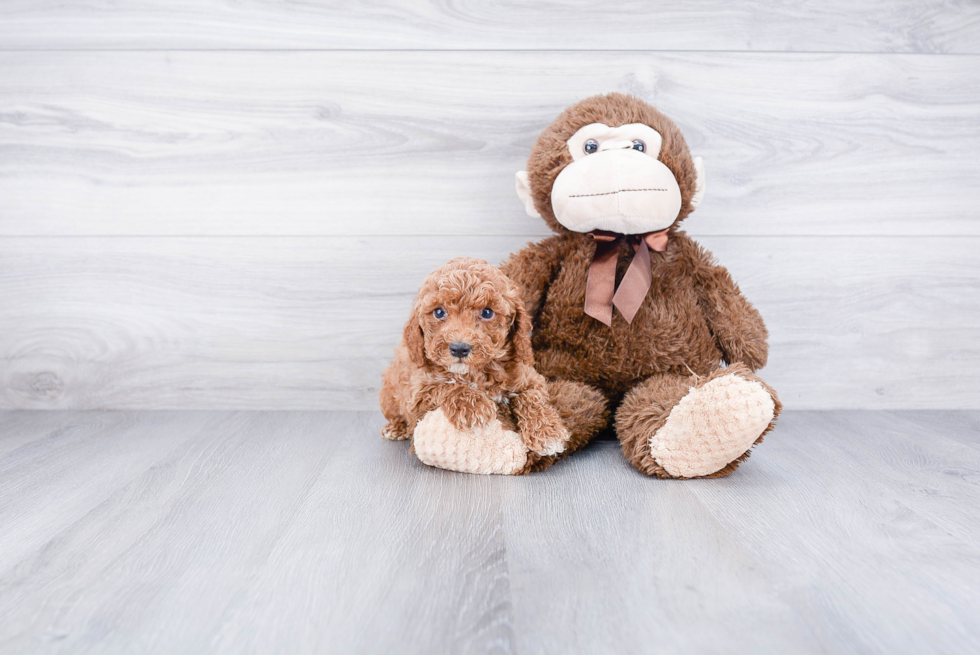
[412, 409, 528, 475]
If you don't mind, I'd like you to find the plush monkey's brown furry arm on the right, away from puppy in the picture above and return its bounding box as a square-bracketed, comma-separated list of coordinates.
[695, 248, 769, 371]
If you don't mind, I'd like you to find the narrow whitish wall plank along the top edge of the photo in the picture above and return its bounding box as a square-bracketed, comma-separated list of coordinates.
[0, 0, 980, 53]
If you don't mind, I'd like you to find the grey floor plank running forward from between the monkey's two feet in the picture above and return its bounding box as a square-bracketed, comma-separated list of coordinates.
[504, 444, 826, 655]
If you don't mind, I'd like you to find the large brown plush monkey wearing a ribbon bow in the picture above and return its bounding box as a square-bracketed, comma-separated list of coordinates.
[502, 93, 781, 478]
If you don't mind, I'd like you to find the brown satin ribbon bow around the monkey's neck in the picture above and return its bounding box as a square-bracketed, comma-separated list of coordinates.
[585, 228, 670, 326]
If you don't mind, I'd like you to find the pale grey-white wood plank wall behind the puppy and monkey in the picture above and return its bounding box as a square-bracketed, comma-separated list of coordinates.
[0, 0, 980, 409]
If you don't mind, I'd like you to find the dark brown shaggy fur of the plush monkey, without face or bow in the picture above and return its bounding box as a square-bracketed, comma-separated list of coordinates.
[502, 93, 781, 477]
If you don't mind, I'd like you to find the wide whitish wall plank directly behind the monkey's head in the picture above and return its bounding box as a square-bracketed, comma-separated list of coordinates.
[0, 51, 980, 236]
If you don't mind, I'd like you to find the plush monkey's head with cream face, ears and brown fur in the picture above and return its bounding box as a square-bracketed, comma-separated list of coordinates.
[517, 94, 704, 234]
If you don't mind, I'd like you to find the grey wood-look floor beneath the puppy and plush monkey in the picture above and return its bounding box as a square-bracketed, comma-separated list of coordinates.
[0, 411, 980, 653]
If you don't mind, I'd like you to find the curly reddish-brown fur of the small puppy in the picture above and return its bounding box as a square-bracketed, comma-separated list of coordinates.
[380, 257, 572, 471]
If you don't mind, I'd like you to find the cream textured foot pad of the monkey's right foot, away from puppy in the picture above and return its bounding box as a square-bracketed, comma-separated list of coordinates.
[650, 375, 776, 478]
